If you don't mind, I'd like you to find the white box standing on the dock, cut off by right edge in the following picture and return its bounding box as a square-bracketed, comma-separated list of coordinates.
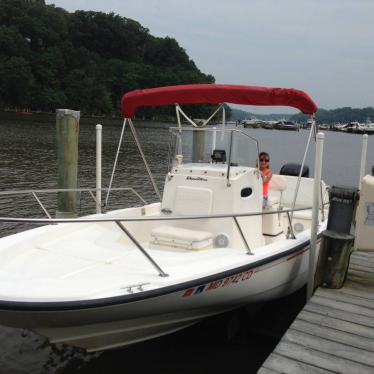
[355, 175, 374, 251]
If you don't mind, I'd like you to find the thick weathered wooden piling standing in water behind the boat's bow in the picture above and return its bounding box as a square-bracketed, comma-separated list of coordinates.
[56, 109, 80, 218]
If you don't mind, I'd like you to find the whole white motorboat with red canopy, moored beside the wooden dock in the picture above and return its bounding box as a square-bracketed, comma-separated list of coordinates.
[0, 85, 328, 351]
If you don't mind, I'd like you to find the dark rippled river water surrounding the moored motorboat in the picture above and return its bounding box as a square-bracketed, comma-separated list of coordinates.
[0, 116, 374, 374]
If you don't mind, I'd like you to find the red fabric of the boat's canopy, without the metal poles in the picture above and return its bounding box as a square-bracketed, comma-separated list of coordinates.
[121, 84, 318, 118]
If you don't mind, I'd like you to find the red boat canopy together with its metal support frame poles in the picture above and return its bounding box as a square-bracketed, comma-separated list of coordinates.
[105, 84, 318, 219]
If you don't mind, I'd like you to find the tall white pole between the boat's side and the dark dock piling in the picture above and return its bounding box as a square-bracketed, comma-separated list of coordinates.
[307, 132, 325, 301]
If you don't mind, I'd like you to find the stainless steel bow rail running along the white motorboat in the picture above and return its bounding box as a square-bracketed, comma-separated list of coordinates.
[0, 205, 329, 277]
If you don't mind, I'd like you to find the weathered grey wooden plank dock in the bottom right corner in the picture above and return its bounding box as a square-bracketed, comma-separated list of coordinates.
[258, 252, 374, 374]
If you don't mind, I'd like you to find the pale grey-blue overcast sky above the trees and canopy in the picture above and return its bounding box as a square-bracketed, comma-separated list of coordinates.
[46, 0, 374, 113]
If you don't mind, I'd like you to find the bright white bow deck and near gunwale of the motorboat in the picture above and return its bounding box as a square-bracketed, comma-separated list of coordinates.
[0, 206, 307, 301]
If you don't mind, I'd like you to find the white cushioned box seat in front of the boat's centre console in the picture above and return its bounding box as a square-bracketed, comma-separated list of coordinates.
[151, 226, 213, 250]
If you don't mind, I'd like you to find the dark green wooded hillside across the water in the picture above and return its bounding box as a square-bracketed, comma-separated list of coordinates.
[0, 0, 219, 118]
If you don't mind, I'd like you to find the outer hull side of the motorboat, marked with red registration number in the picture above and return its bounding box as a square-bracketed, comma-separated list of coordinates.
[0, 242, 309, 351]
